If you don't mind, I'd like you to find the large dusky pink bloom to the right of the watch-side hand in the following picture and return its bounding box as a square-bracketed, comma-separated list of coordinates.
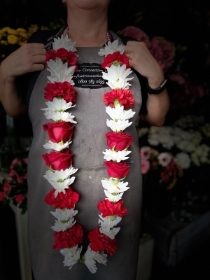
[150, 37, 175, 70]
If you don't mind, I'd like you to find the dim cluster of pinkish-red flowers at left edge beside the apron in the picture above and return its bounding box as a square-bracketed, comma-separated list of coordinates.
[0, 158, 28, 214]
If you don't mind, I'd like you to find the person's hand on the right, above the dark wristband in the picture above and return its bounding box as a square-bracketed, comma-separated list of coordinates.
[125, 41, 164, 88]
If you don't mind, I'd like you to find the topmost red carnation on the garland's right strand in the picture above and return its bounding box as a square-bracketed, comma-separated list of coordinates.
[101, 52, 130, 68]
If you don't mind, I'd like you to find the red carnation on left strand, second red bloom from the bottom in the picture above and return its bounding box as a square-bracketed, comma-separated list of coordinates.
[45, 188, 79, 209]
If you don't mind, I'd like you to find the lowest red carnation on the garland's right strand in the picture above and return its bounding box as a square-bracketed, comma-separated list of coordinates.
[88, 228, 117, 255]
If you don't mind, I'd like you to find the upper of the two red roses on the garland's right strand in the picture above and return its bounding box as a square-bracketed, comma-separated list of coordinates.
[106, 131, 133, 151]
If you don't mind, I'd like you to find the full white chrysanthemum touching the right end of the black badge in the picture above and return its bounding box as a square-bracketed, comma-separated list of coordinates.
[102, 64, 133, 89]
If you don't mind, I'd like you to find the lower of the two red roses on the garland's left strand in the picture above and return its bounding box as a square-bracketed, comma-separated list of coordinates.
[42, 150, 73, 170]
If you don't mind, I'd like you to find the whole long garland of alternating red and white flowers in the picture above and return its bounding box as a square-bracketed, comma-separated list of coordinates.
[42, 35, 135, 273]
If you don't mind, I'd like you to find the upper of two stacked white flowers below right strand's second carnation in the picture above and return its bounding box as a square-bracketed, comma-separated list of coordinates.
[106, 104, 135, 121]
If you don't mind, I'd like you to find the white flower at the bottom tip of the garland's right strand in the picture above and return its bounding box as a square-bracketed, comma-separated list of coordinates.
[84, 246, 107, 273]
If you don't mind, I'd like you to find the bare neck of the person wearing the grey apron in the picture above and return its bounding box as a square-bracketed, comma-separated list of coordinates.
[67, 11, 108, 47]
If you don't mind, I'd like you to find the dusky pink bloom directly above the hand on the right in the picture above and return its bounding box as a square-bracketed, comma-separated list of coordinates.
[121, 26, 150, 47]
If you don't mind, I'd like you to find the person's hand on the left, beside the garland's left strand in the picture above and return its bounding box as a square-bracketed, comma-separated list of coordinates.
[1, 43, 46, 81]
